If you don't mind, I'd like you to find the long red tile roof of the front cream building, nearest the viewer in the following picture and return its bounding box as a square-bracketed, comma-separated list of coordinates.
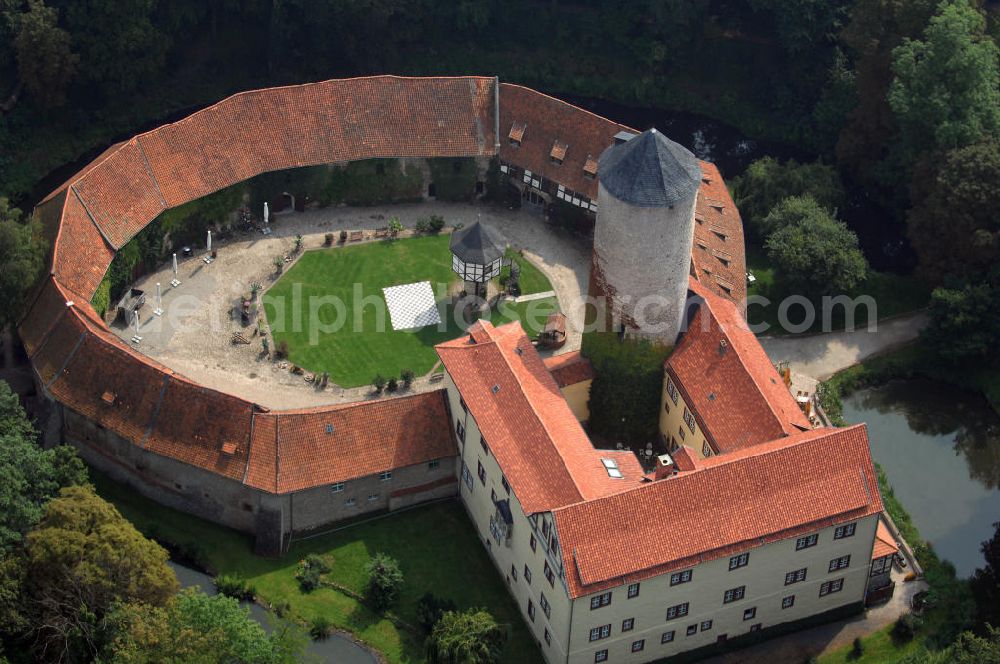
[554, 425, 882, 597]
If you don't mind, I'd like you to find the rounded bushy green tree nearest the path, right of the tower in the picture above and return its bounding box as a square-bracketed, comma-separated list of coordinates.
[765, 197, 868, 296]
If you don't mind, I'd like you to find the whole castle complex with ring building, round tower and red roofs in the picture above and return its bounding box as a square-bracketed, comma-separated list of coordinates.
[19, 76, 896, 664]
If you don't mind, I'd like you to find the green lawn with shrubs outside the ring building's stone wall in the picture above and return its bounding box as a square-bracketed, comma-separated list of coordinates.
[91, 470, 541, 664]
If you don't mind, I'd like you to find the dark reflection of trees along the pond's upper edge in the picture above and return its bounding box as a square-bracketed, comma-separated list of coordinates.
[857, 380, 1000, 489]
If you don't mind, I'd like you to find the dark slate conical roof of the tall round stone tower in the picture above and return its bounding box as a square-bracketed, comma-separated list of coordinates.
[598, 129, 701, 207]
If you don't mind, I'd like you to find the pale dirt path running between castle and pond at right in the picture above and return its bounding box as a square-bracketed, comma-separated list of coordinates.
[760, 311, 927, 380]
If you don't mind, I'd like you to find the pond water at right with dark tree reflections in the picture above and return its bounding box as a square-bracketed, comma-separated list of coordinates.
[844, 380, 1000, 577]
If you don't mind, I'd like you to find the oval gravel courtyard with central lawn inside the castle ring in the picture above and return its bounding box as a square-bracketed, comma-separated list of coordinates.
[111, 202, 590, 409]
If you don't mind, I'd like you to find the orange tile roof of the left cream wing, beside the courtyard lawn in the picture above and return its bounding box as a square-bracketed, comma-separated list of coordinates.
[437, 321, 642, 514]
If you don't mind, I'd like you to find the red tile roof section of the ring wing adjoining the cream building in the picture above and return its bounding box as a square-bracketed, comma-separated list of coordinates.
[247, 390, 458, 493]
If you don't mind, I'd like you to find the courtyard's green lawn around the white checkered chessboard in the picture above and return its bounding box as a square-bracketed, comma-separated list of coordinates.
[264, 235, 558, 387]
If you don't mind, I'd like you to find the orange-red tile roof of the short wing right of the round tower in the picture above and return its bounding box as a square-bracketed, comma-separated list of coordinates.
[666, 281, 811, 452]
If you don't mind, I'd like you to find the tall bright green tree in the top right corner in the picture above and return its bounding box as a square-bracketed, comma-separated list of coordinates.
[888, 0, 1000, 161]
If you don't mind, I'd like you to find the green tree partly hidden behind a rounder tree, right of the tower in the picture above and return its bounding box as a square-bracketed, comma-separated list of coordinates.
[732, 157, 844, 240]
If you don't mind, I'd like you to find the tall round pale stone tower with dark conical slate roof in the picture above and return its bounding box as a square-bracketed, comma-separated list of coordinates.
[591, 129, 701, 344]
